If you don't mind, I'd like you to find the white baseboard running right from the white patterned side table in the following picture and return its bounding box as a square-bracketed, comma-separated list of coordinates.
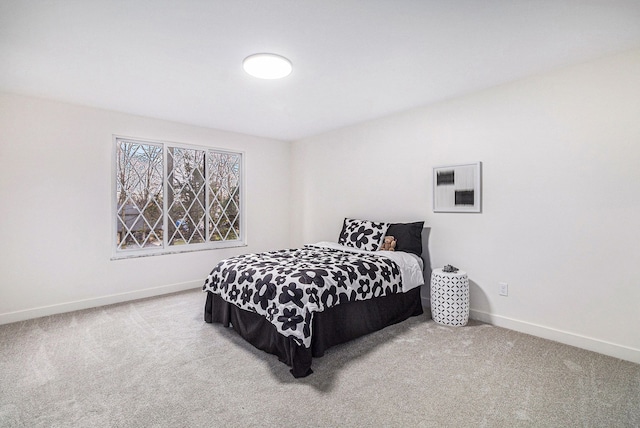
[469, 309, 640, 364]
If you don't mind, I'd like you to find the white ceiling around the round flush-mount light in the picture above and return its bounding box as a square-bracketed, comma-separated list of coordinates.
[0, 0, 640, 140]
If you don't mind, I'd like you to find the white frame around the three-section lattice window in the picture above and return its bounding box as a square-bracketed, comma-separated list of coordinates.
[111, 135, 247, 260]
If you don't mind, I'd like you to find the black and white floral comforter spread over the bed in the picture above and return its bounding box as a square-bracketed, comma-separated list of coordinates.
[203, 245, 402, 348]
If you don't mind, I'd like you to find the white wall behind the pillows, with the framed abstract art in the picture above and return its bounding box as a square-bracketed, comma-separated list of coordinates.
[292, 51, 640, 362]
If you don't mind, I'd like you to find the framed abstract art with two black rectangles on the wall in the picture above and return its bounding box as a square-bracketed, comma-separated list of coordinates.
[433, 162, 482, 213]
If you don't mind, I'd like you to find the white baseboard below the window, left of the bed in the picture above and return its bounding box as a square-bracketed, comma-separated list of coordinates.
[0, 280, 202, 325]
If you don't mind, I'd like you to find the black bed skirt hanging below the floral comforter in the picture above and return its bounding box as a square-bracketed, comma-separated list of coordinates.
[204, 287, 423, 377]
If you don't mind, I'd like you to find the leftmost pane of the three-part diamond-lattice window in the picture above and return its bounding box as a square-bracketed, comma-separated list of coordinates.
[116, 140, 163, 250]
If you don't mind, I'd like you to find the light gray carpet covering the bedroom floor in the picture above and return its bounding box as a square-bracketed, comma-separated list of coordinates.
[0, 290, 640, 427]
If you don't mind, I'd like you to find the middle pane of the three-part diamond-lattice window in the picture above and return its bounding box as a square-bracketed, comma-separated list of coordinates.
[167, 147, 206, 245]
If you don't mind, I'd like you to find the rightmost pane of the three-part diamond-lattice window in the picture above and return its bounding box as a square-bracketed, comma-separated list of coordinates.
[207, 151, 242, 241]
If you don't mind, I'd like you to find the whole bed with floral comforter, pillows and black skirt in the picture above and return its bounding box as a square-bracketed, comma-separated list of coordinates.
[203, 218, 428, 378]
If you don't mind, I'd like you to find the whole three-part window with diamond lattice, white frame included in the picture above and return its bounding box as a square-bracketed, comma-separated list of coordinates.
[114, 137, 244, 258]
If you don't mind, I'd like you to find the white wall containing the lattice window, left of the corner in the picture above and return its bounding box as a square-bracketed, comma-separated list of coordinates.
[0, 94, 291, 323]
